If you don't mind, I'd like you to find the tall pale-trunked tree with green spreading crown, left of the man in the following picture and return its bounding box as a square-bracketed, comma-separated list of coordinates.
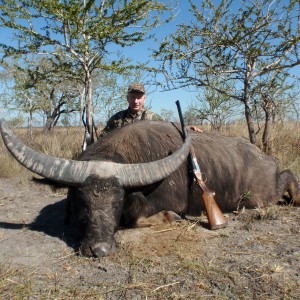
[0, 0, 173, 141]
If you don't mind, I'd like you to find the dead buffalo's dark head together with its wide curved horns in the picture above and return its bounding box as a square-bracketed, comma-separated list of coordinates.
[0, 120, 191, 257]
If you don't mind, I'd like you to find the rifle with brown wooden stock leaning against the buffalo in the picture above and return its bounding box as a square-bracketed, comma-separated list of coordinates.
[175, 100, 228, 230]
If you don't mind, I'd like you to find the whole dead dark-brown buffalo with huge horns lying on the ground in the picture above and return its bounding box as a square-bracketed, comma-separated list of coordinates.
[0, 120, 300, 257]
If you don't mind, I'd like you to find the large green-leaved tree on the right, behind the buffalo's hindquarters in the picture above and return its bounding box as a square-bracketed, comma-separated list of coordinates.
[153, 0, 300, 144]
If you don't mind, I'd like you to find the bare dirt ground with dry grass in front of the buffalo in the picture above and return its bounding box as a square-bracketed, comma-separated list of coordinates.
[0, 179, 300, 299]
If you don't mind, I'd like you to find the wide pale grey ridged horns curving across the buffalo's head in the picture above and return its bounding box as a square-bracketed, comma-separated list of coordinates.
[0, 119, 192, 187]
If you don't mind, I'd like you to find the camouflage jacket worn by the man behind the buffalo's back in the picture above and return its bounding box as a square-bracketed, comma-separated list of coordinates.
[101, 108, 162, 136]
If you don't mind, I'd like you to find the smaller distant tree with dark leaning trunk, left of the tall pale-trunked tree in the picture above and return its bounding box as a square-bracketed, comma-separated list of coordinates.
[12, 58, 80, 132]
